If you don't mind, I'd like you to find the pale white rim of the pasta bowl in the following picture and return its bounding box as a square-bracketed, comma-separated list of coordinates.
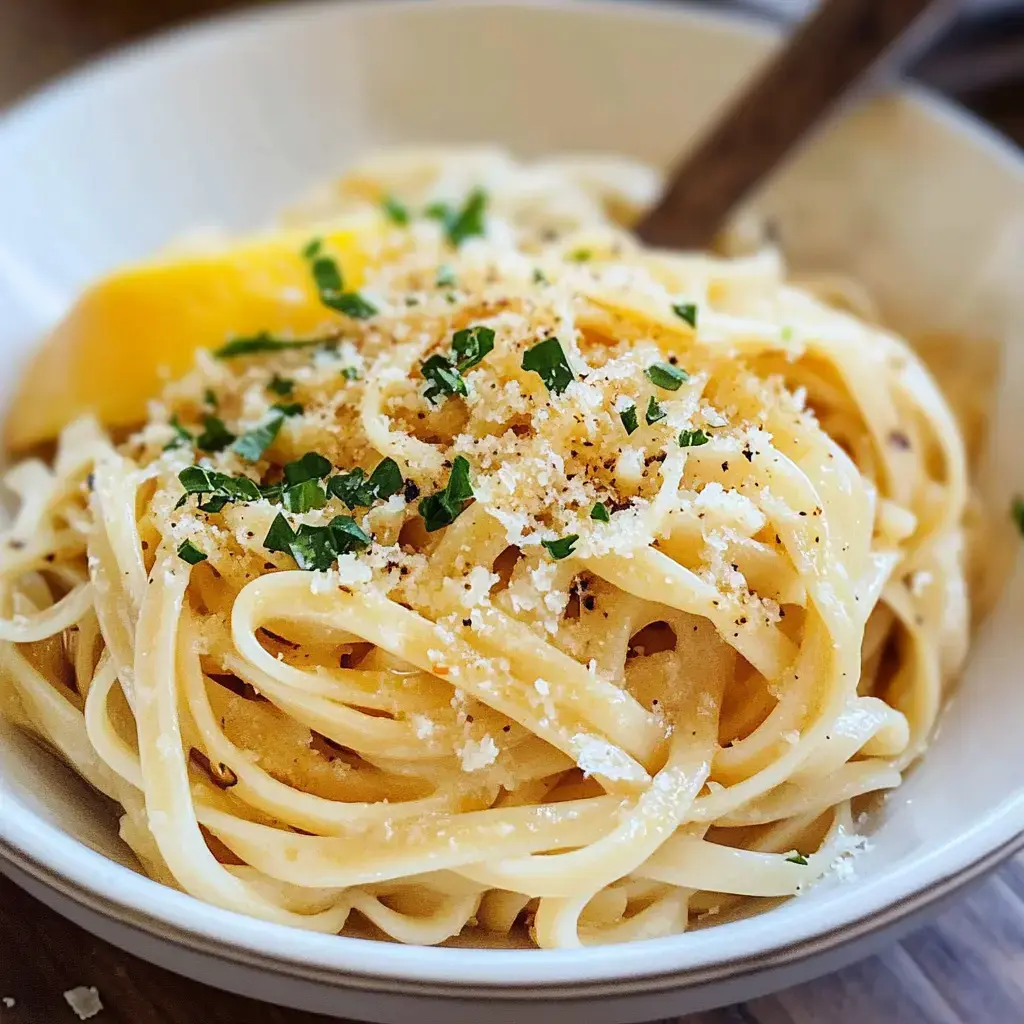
[0, 0, 1024, 998]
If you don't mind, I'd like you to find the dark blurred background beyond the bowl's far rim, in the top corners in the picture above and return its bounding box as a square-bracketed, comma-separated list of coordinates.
[0, 0, 1024, 143]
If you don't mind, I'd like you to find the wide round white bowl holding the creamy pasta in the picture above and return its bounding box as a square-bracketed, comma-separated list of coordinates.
[0, 0, 1024, 1024]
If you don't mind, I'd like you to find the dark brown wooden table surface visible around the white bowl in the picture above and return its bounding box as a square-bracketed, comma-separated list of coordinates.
[0, 0, 1024, 1024]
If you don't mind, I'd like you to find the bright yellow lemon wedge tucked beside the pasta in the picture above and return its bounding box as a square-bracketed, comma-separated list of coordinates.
[4, 219, 374, 452]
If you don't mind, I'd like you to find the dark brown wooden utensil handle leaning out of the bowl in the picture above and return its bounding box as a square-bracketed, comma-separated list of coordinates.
[637, 0, 955, 249]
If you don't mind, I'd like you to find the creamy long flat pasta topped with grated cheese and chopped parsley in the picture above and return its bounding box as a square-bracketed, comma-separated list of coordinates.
[0, 152, 969, 948]
